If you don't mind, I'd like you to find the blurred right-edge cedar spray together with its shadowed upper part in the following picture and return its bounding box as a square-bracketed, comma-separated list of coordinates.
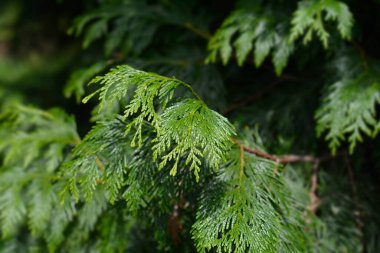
[316, 51, 380, 154]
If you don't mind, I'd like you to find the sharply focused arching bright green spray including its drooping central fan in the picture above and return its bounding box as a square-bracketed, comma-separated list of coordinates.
[83, 65, 235, 180]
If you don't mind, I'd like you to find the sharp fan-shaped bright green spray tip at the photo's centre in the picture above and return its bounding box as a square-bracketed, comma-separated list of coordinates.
[153, 99, 234, 181]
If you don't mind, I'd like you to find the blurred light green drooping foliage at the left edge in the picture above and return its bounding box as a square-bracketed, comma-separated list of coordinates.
[0, 105, 79, 251]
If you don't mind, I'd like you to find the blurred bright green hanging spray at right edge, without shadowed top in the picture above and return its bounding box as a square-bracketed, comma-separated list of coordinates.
[316, 77, 380, 154]
